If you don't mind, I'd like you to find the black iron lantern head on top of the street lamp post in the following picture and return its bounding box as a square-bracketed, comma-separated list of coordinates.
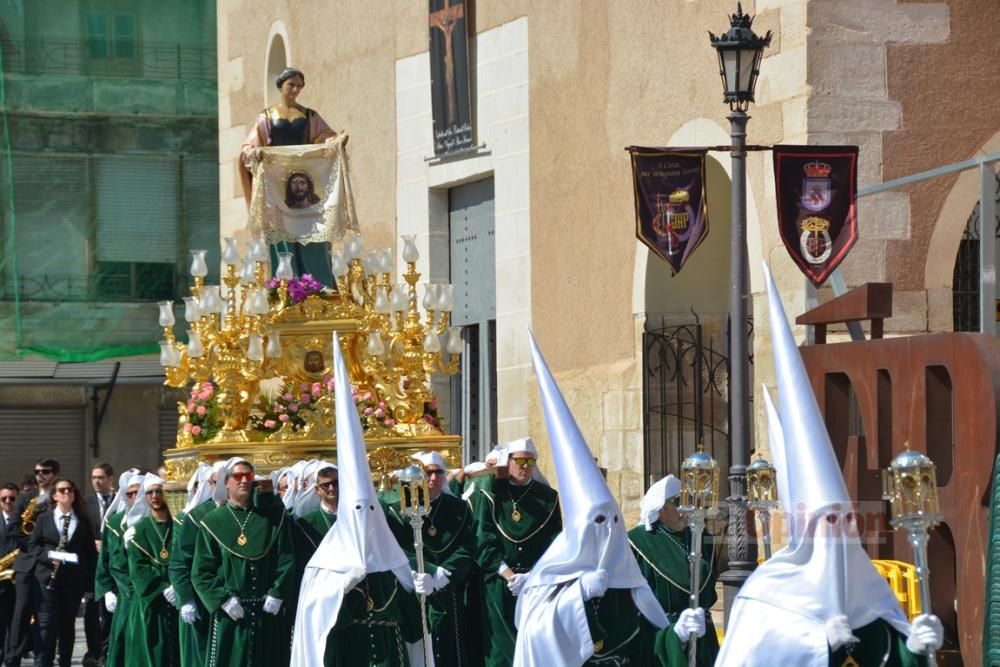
[708, 3, 771, 111]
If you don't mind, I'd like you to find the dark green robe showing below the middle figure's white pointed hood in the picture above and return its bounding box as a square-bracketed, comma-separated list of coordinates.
[583, 588, 655, 667]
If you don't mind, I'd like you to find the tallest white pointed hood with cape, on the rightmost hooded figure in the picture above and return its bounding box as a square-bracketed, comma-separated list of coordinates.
[716, 264, 909, 667]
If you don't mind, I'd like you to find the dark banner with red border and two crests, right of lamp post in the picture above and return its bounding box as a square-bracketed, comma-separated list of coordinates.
[774, 146, 858, 287]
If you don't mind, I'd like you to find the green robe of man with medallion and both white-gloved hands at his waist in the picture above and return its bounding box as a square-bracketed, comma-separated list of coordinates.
[191, 503, 295, 667]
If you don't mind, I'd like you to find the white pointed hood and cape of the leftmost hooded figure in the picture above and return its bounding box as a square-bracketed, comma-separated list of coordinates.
[291, 333, 413, 667]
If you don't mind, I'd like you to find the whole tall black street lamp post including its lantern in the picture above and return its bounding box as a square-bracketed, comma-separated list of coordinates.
[708, 3, 771, 622]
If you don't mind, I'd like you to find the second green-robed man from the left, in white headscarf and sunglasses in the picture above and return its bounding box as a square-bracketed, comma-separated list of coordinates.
[127, 475, 180, 667]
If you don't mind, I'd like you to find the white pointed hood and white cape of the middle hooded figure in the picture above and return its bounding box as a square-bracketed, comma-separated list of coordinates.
[508, 336, 669, 667]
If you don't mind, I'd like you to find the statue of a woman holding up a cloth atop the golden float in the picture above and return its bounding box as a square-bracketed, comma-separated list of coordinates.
[240, 68, 339, 287]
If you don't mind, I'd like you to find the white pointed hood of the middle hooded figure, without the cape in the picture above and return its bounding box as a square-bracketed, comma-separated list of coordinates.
[512, 337, 668, 627]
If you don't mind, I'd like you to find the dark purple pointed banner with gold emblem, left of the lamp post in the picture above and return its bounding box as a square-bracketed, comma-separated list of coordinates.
[628, 146, 708, 274]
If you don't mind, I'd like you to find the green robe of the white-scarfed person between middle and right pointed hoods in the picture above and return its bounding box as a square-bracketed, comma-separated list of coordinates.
[628, 522, 719, 667]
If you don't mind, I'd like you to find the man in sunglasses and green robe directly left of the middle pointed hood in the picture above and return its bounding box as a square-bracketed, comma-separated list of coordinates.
[471, 438, 562, 667]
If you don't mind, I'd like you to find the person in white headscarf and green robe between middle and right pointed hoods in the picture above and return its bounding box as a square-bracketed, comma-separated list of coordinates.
[628, 475, 719, 667]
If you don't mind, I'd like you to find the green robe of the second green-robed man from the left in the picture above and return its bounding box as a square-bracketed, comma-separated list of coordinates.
[126, 515, 180, 667]
